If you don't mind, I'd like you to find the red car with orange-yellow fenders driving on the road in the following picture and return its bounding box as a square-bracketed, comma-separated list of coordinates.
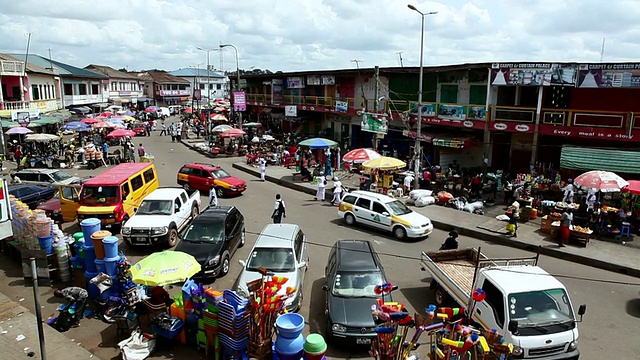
[178, 162, 247, 197]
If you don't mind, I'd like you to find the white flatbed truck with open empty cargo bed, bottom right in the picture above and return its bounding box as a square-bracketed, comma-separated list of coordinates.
[420, 248, 587, 360]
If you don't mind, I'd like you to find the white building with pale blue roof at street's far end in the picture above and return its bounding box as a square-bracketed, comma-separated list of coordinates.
[171, 68, 229, 104]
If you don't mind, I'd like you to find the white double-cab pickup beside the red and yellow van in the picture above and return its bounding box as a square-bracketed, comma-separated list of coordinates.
[121, 187, 200, 247]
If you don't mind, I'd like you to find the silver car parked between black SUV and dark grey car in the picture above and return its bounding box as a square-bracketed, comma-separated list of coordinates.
[237, 224, 308, 316]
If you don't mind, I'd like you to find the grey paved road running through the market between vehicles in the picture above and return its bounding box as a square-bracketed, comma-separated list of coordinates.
[5, 128, 640, 359]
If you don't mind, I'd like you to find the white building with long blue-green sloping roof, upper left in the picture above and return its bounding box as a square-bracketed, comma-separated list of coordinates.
[13, 54, 109, 108]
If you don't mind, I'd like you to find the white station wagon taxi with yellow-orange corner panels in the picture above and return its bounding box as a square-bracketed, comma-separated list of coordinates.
[338, 191, 433, 240]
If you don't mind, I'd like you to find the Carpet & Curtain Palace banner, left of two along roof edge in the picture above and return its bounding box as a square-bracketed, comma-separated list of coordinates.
[491, 63, 577, 86]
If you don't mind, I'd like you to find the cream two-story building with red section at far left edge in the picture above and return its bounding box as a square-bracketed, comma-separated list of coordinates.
[0, 54, 63, 117]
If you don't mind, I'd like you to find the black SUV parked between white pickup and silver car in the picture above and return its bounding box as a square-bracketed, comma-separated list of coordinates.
[175, 206, 247, 278]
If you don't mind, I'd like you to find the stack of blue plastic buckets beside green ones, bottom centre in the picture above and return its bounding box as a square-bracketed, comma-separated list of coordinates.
[274, 313, 305, 360]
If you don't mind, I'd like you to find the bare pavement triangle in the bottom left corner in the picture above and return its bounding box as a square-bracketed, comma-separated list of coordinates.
[0, 293, 99, 360]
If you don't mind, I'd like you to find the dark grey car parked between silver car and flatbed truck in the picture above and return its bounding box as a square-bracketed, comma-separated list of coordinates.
[322, 240, 392, 346]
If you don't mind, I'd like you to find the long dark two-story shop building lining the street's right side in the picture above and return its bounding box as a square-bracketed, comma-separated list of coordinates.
[245, 63, 640, 174]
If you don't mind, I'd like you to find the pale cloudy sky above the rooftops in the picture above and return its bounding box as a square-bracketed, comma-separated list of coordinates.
[0, 0, 640, 71]
